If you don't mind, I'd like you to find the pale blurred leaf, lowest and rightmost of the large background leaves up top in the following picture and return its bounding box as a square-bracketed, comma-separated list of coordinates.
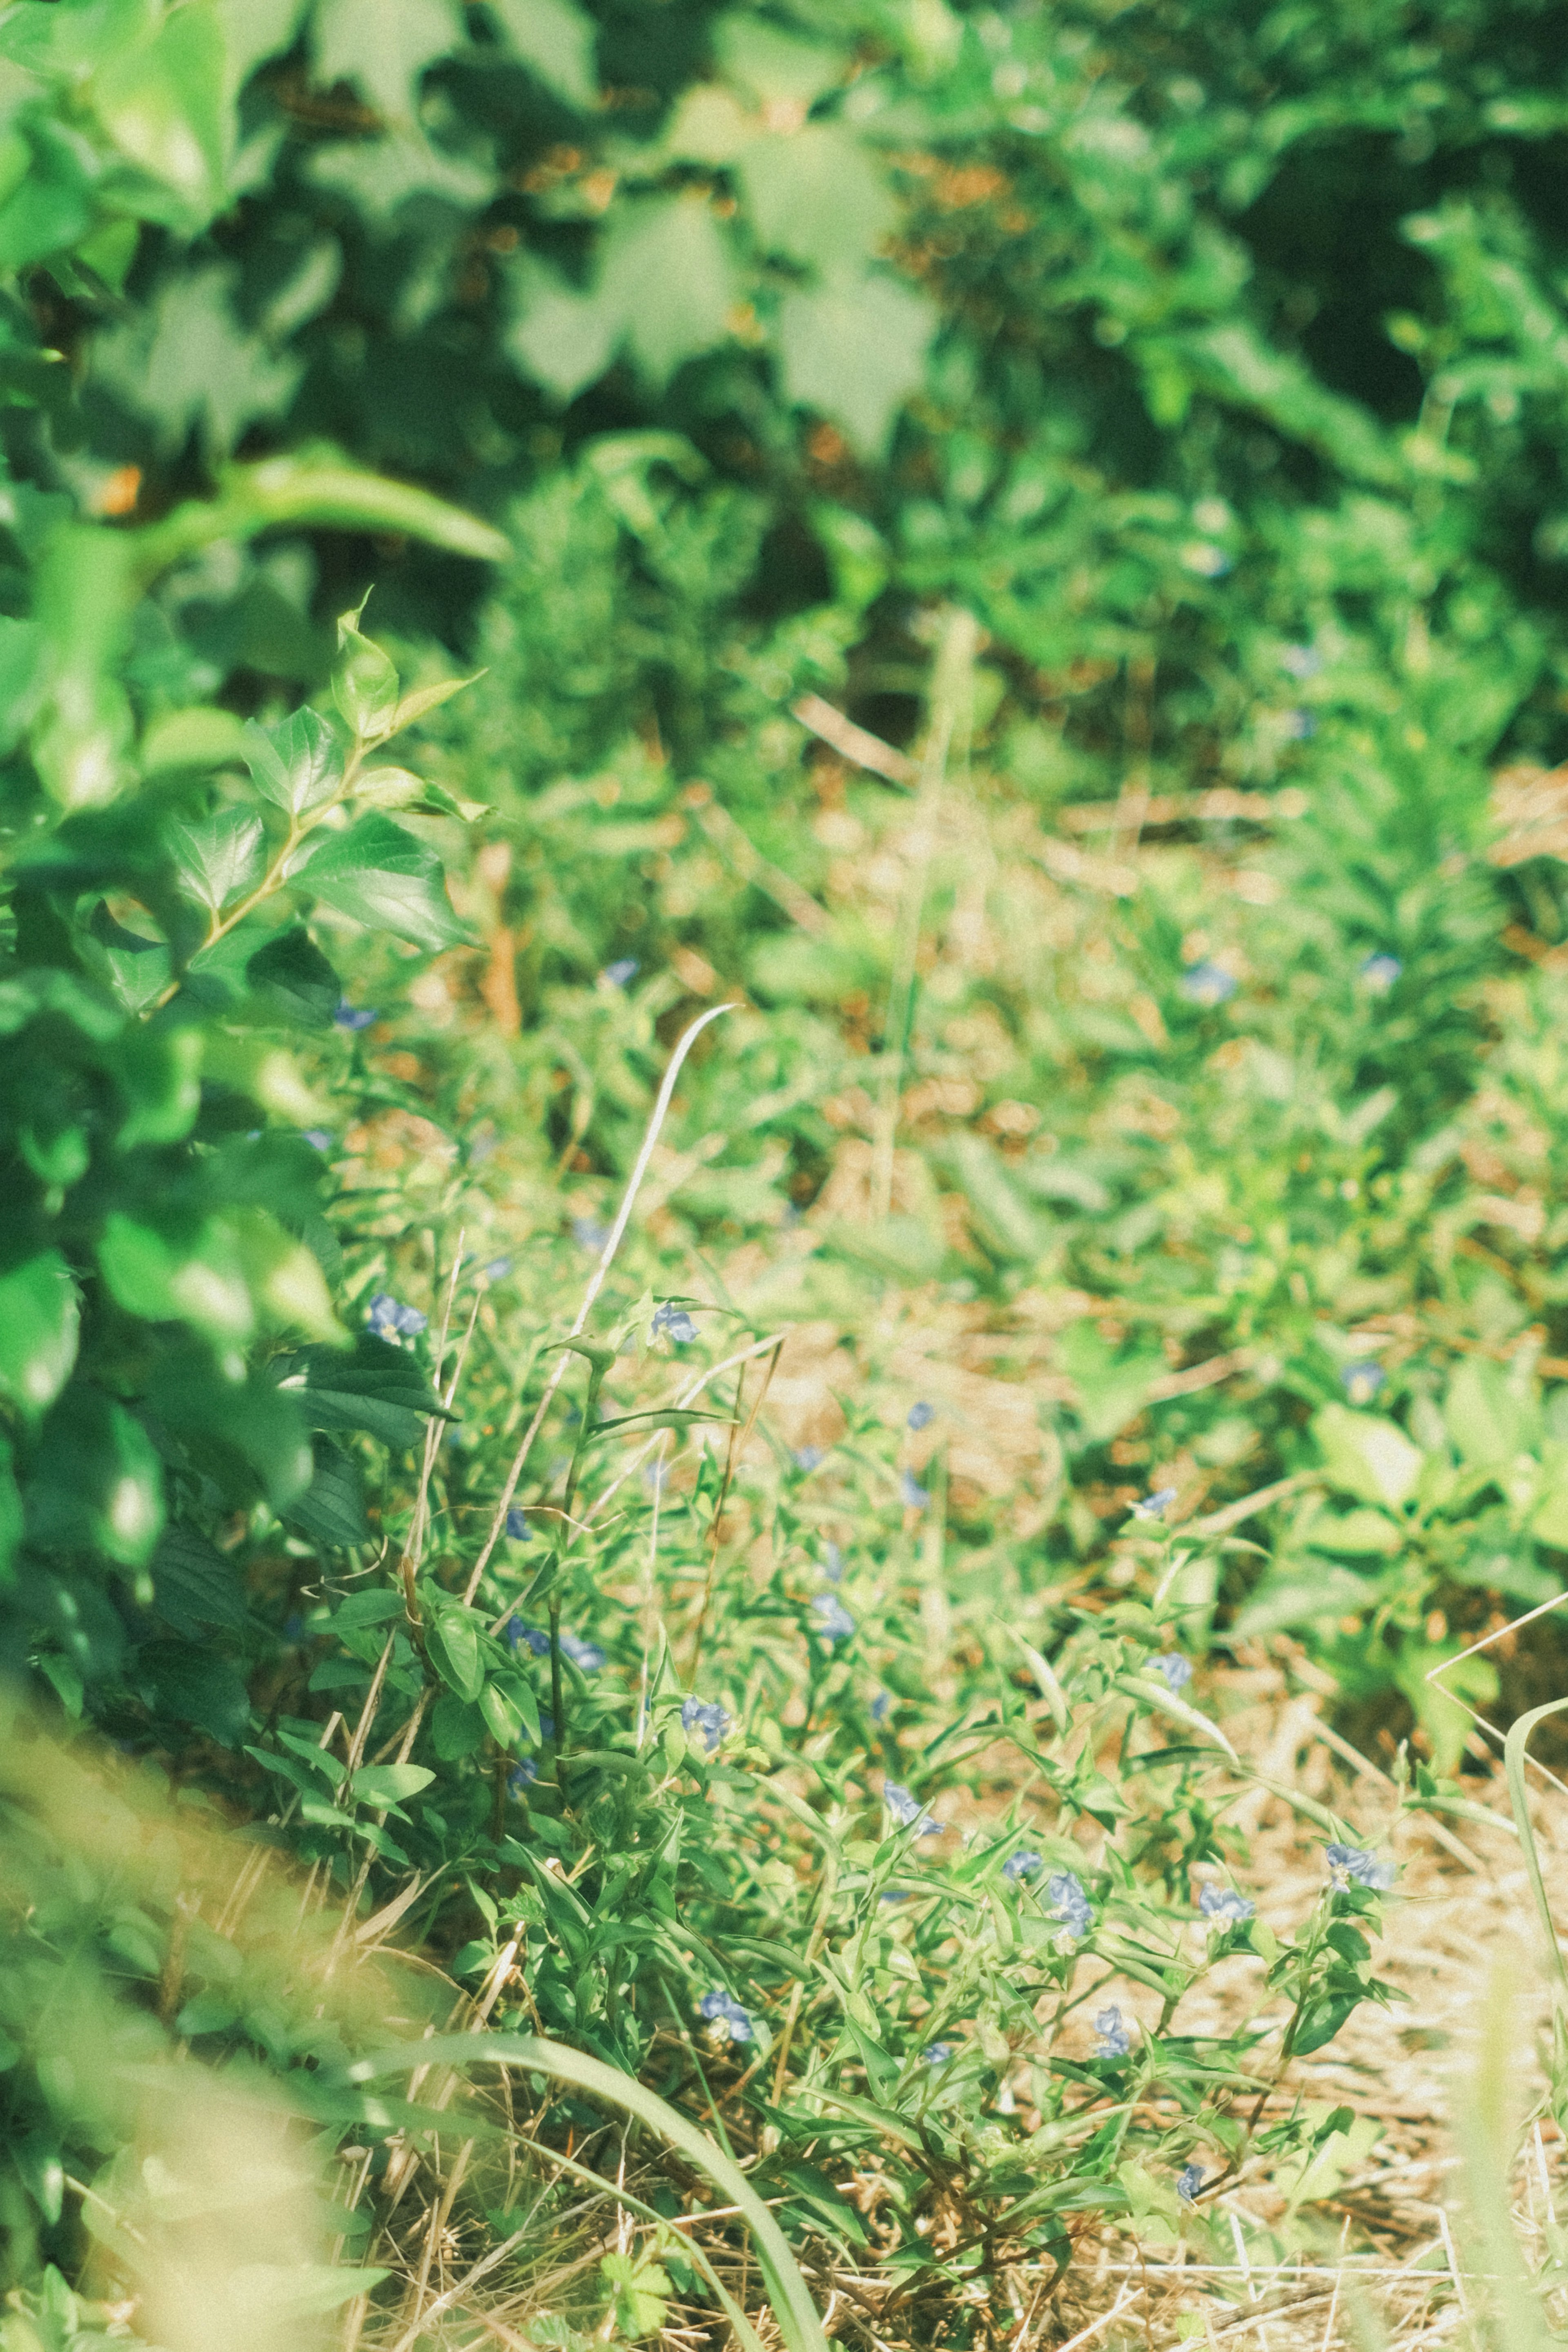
[778, 275, 935, 456]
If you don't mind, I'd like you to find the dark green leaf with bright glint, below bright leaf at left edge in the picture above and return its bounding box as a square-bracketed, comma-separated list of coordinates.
[26, 1383, 165, 1569]
